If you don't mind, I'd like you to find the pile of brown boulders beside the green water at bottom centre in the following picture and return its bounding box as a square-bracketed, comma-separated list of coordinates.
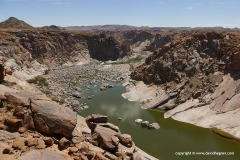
[86, 114, 157, 160]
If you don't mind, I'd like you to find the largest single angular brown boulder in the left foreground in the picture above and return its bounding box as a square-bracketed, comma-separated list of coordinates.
[31, 100, 77, 138]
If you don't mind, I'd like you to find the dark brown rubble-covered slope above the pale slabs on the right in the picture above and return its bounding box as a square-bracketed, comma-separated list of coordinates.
[131, 31, 240, 108]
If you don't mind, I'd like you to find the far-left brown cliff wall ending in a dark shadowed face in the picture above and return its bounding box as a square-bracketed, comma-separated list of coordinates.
[0, 30, 123, 65]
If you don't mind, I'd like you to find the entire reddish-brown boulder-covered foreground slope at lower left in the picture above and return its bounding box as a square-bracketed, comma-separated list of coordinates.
[0, 85, 158, 160]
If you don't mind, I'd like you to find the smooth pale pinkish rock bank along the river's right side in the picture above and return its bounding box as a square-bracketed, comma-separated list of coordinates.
[123, 75, 240, 141]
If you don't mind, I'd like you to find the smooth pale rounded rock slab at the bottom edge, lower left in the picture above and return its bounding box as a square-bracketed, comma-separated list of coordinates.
[18, 149, 66, 160]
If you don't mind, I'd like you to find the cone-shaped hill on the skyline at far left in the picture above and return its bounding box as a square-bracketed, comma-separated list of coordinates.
[0, 17, 33, 29]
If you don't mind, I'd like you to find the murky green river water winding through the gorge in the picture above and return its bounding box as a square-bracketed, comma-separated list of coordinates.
[79, 84, 240, 160]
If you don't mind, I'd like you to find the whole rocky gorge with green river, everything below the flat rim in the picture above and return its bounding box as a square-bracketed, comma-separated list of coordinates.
[0, 19, 240, 160]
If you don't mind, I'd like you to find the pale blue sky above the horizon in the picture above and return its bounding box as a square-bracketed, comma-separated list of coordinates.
[0, 0, 240, 27]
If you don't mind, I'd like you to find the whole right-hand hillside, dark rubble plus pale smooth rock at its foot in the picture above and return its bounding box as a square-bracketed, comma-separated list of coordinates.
[131, 31, 240, 139]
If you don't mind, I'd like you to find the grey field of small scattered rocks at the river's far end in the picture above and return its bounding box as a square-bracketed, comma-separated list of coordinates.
[39, 61, 129, 112]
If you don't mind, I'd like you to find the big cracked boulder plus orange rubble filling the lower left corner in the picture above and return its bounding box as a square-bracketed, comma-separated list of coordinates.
[0, 85, 77, 159]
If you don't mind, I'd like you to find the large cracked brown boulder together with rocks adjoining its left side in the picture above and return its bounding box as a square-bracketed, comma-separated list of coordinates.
[0, 85, 77, 138]
